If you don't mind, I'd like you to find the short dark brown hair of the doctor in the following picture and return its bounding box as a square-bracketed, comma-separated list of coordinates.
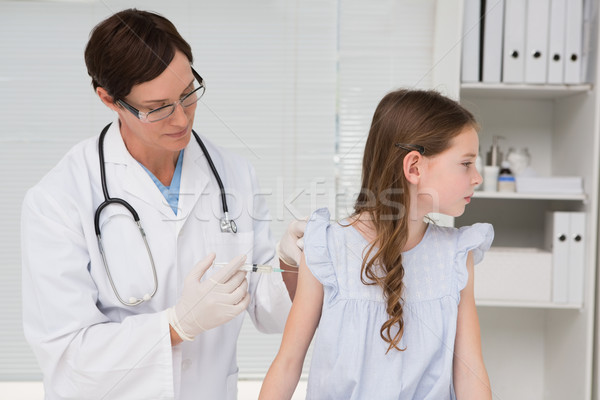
[85, 9, 193, 101]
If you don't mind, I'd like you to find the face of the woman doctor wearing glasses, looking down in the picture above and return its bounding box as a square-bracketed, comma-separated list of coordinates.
[117, 51, 196, 152]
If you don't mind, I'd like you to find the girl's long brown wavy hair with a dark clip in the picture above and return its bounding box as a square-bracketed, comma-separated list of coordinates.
[353, 90, 478, 352]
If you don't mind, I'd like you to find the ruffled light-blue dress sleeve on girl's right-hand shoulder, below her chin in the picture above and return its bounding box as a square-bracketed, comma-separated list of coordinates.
[454, 223, 494, 291]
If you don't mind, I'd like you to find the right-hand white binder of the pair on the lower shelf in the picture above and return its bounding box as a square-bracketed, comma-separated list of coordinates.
[568, 212, 586, 304]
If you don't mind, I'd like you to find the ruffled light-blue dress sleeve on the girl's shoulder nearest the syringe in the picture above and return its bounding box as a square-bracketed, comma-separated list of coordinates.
[304, 208, 338, 295]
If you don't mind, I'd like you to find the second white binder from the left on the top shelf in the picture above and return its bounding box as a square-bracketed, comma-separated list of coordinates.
[482, 0, 504, 83]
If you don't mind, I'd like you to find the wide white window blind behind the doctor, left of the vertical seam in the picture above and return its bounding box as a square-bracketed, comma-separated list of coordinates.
[0, 0, 336, 380]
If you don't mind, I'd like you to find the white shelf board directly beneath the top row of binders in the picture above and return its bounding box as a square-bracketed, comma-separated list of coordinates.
[460, 83, 592, 100]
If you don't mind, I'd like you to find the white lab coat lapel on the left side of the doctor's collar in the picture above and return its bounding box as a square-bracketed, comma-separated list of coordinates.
[104, 119, 176, 220]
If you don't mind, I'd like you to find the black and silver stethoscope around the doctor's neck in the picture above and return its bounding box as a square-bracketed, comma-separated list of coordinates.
[94, 124, 237, 306]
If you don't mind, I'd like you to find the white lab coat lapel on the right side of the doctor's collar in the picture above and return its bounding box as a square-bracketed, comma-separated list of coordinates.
[177, 135, 211, 233]
